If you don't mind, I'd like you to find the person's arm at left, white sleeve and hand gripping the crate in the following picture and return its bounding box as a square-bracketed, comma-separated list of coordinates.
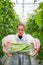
[2, 36, 12, 57]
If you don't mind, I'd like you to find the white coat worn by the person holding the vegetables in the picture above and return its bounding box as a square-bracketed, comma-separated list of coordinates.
[2, 33, 39, 65]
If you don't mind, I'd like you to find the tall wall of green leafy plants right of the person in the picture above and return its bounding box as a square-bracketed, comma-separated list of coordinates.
[26, 2, 43, 60]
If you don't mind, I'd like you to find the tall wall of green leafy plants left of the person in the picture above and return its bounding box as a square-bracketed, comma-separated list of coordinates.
[0, 0, 20, 56]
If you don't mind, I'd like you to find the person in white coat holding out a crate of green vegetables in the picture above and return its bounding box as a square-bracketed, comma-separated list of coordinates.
[2, 23, 39, 65]
